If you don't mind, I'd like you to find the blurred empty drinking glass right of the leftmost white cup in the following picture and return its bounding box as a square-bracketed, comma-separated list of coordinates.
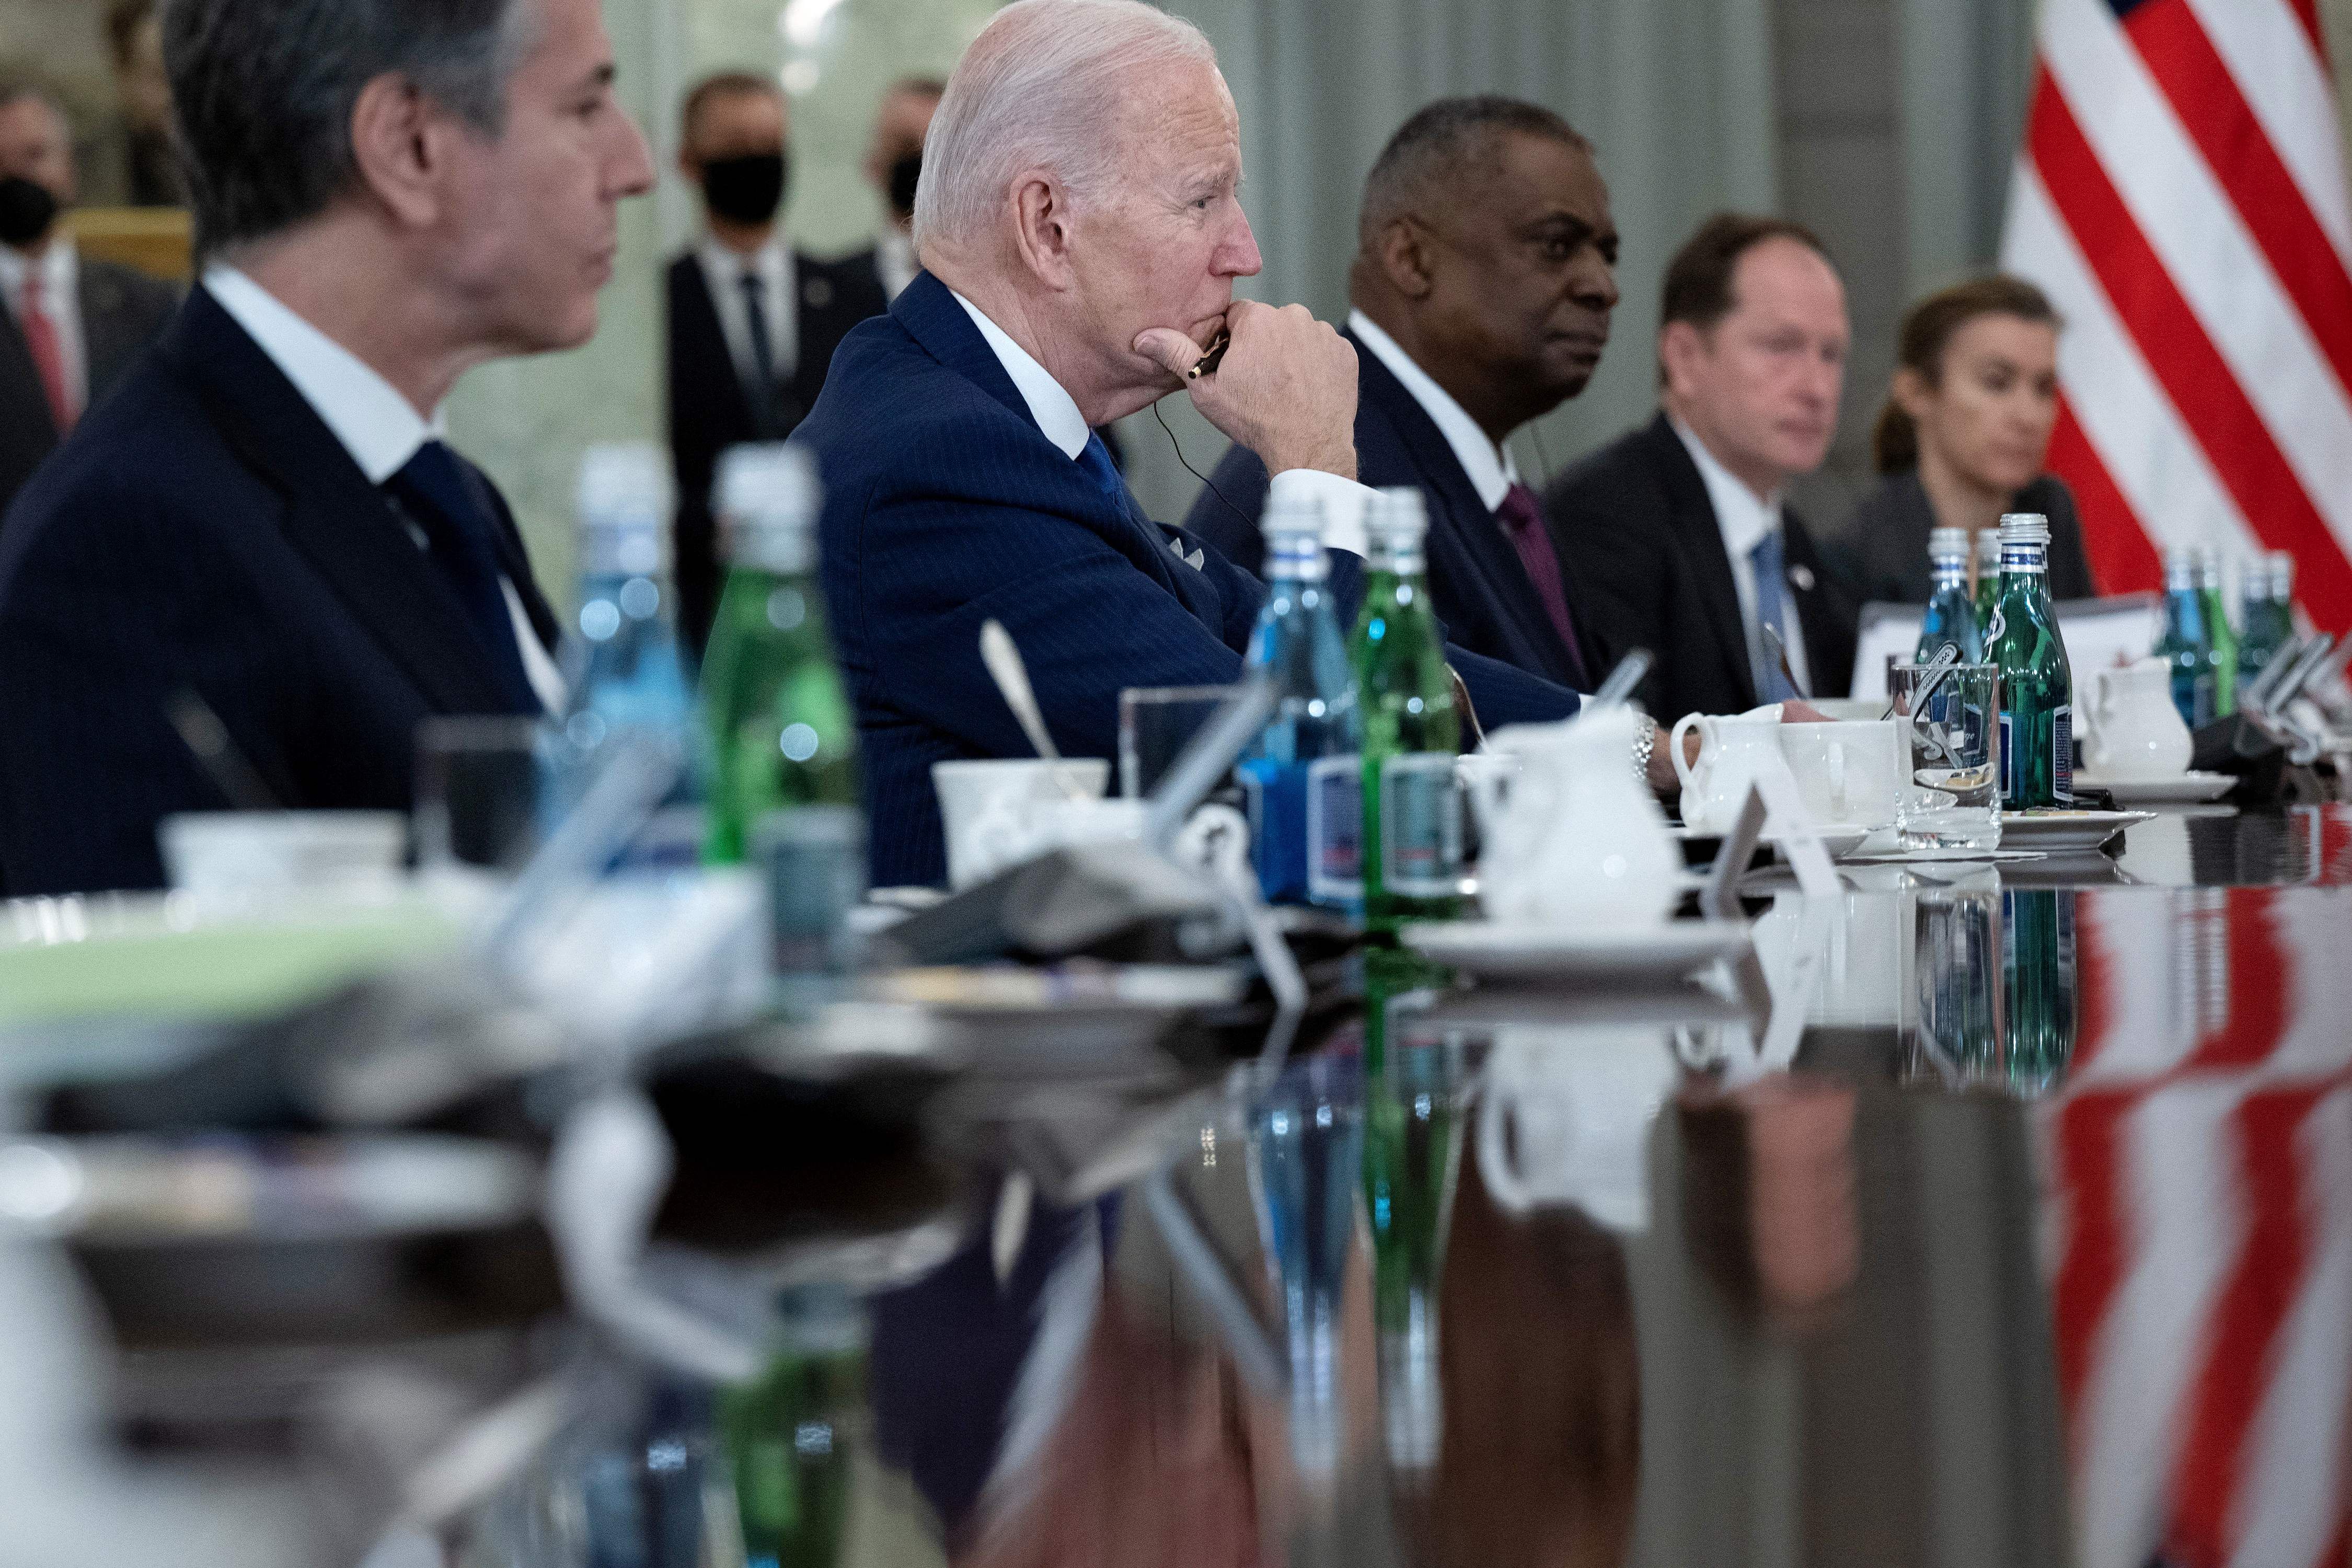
[417, 714, 553, 870]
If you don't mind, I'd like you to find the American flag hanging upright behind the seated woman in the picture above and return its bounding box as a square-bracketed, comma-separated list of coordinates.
[2002, 0, 2352, 630]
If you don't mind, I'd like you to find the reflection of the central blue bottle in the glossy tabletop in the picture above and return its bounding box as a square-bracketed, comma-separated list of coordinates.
[1249, 1055, 1364, 1474]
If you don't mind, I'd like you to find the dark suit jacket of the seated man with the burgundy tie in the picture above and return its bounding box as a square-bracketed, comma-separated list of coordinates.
[1185, 334, 1599, 686]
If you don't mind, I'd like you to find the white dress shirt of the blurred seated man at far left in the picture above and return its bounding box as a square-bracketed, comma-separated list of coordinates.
[205, 266, 564, 712]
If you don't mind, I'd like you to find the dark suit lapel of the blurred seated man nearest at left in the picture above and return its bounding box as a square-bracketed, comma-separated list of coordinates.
[163, 287, 529, 712]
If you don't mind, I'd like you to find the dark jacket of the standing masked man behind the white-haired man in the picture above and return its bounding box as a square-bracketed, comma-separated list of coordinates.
[671, 249, 884, 658]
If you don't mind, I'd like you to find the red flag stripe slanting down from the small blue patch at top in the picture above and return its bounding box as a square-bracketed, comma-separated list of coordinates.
[2124, 0, 2352, 395]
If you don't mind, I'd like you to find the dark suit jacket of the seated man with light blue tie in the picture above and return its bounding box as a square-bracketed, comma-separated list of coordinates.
[1543, 414, 1858, 724]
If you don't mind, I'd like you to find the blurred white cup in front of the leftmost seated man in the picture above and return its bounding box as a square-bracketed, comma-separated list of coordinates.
[155, 811, 409, 893]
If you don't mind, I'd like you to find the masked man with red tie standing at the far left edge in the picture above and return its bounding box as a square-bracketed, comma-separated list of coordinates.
[0, 85, 179, 513]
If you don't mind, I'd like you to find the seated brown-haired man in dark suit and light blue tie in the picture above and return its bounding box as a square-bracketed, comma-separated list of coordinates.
[1543, 214, 1858, 719]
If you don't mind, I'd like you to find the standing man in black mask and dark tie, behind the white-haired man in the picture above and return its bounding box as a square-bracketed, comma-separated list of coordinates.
[668, 71, 887, 656]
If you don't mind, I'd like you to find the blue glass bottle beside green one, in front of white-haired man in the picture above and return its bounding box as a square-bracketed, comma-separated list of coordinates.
[1240, 501, 1364, 910]
